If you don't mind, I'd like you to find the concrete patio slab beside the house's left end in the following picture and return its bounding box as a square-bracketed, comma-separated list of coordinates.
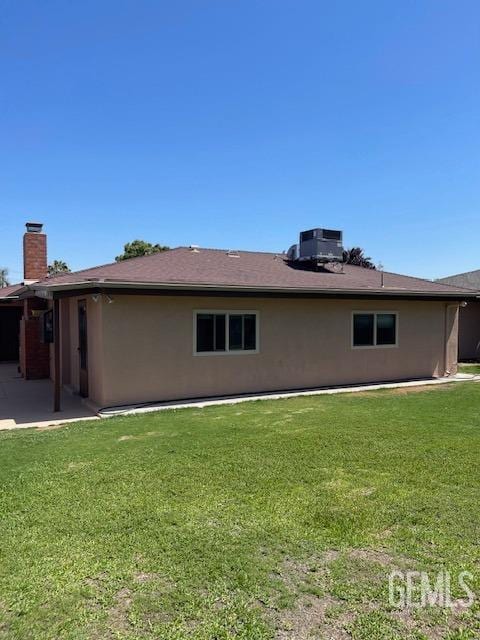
[0, 364, 98, 430]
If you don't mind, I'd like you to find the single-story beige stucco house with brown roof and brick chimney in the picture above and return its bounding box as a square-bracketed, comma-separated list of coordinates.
[0, 222, 477, 409]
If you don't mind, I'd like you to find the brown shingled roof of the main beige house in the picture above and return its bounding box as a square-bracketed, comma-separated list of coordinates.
[31, 247, 474, 298]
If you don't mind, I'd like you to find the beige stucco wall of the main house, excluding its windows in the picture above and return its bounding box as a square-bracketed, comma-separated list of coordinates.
[70, 295, 457, 406]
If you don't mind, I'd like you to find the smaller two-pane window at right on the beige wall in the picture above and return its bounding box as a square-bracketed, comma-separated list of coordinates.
[352, 311, 398, 347]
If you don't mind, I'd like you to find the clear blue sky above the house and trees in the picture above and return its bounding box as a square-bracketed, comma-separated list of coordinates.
[0, 0, 480, 280]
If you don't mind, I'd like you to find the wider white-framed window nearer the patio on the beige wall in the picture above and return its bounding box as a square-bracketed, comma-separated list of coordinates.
[194, 311, 258, 355]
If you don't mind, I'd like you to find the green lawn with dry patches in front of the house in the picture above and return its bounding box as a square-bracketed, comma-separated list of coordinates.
[0, 382, 480, 640]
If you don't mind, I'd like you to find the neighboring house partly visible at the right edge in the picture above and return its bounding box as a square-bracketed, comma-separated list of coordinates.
[437, 269, 480, 360]
